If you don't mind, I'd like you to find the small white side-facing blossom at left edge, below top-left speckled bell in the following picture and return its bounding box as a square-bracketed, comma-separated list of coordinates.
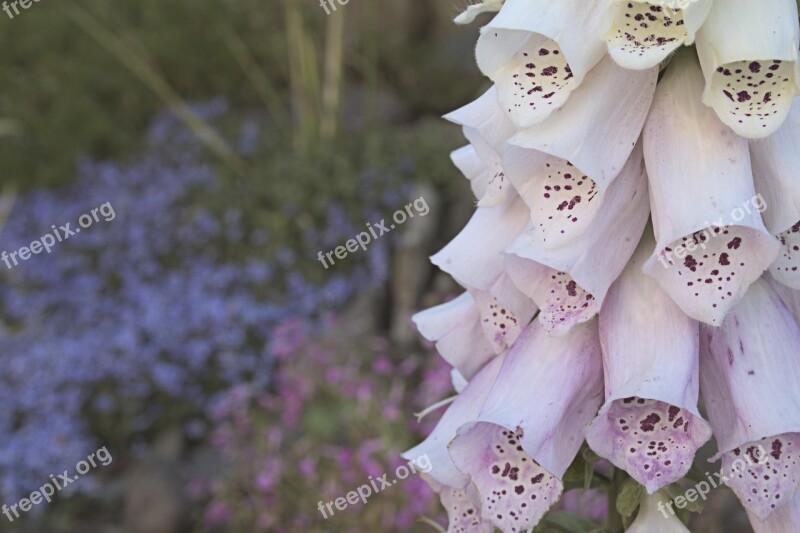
[445, 87, 516, 207]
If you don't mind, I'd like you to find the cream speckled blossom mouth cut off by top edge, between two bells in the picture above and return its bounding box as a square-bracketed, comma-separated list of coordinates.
[606, 0, 713, 69]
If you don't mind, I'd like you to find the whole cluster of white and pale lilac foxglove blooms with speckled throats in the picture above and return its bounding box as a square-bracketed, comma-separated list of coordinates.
[406, 0, 800, 533]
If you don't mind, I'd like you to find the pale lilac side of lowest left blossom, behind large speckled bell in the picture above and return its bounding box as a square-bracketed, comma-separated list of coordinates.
[403, 356, 505, 490]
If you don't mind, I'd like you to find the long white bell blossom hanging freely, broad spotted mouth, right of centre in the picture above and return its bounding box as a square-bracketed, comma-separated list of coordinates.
[644, 49, 778, 325]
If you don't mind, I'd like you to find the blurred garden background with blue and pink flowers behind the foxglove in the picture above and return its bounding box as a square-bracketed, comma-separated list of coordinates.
[0, 0, 748, 533]
